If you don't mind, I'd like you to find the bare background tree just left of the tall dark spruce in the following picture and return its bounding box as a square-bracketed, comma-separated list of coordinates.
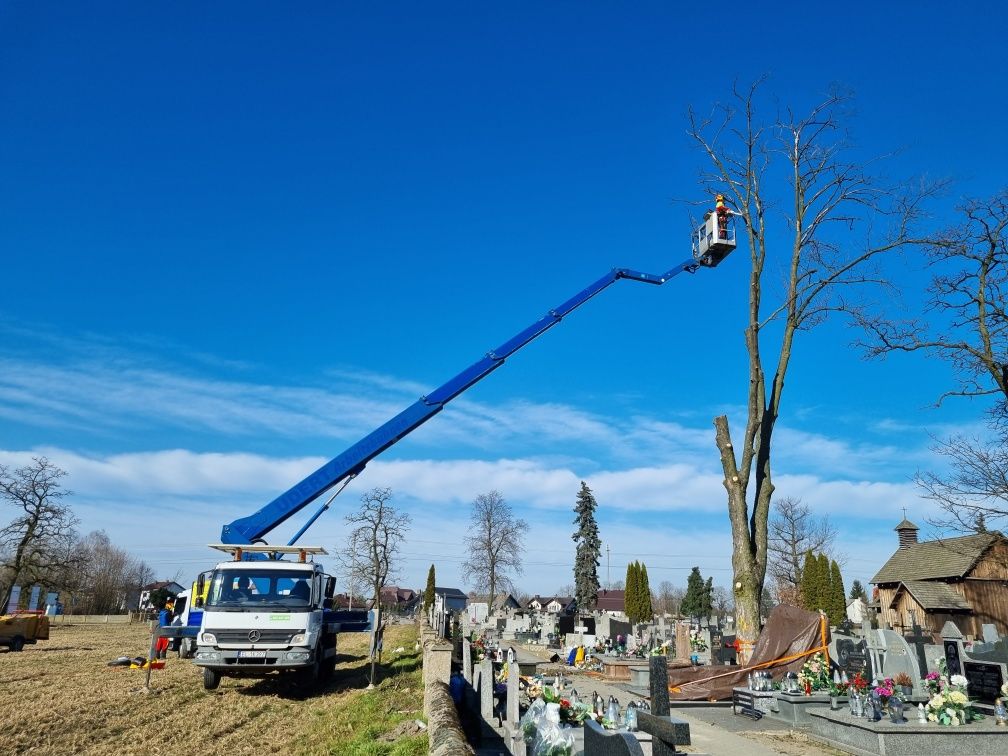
[462, 491, 528, 608]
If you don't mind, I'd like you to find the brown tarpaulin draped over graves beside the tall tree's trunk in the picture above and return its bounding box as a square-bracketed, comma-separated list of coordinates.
[668, 604, 829, 701]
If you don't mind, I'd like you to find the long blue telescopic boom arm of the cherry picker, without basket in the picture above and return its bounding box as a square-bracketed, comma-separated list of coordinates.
[221, 257, 701, 545]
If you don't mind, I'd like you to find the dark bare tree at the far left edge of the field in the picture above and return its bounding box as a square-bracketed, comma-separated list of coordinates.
[0, 457, 77, 610]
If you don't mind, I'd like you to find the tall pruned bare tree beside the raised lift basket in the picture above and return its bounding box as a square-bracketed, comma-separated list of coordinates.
[689, 82, 933, 661]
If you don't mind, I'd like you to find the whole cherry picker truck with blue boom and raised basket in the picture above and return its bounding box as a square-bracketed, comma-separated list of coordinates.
[190, 213, 736, 689]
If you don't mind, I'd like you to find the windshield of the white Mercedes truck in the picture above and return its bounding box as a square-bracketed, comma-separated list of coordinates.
[207, 566, 312, 611]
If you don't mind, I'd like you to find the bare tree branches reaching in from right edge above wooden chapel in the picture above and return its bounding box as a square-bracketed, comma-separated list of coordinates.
[859, 190, 1008, 531]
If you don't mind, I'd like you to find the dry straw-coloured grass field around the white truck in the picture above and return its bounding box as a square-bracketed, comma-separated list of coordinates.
[0, 625, 427, 756]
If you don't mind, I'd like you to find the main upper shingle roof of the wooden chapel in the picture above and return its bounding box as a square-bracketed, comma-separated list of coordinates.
[872, 532, 1003, 586]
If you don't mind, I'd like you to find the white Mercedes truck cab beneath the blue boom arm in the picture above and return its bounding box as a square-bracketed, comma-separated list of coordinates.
[194, 544, 358, 690]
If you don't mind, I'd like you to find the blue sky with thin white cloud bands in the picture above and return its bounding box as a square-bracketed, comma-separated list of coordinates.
[0, 2, 1008, 593]
